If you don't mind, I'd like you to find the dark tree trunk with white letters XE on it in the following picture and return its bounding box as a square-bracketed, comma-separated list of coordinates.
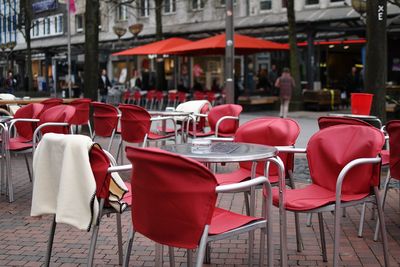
[364, 0, 387, 123]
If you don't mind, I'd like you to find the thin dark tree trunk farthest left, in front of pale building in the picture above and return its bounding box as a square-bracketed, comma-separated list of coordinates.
[20, 0, 33, 91]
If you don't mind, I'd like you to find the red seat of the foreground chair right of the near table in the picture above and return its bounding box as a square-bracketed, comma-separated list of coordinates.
[272, 184, 368, 211]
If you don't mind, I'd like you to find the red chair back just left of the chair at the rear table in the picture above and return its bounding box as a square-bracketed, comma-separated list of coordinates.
[92, 102, 118, 137]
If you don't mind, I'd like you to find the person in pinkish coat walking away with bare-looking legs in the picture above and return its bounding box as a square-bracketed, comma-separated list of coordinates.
[275, 68, 295, 118]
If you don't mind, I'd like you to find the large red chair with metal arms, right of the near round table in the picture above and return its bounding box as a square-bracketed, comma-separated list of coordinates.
[273, 125, 389, 266]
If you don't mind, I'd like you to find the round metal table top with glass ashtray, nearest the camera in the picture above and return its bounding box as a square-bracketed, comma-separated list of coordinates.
[161, 142, 278, 163]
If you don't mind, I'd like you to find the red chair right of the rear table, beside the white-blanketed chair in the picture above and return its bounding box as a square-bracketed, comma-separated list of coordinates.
[188, 104, 243, 138]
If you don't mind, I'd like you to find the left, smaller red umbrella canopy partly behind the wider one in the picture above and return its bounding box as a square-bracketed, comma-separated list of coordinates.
[112, 38, 192, 56]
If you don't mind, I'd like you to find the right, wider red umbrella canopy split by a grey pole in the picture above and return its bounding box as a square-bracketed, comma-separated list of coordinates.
[164, 34, 288, 55]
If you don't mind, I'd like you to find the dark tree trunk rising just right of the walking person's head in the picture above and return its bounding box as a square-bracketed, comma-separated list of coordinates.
[286, 0, 302, 109]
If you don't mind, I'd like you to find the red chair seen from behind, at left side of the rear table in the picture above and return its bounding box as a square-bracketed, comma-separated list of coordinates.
[116, 105, 176, 163]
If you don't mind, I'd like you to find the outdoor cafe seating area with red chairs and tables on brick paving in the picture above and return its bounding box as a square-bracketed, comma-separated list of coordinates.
[0, 97, 400, 266]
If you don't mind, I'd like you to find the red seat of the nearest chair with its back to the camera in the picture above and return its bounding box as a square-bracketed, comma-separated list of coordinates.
[208, 208, 262, 235]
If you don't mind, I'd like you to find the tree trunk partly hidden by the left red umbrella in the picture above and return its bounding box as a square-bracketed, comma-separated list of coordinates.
[154, 0, 166, 90]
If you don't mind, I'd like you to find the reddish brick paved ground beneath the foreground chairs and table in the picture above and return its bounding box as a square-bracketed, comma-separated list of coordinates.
[0, 116, 400, 266]
